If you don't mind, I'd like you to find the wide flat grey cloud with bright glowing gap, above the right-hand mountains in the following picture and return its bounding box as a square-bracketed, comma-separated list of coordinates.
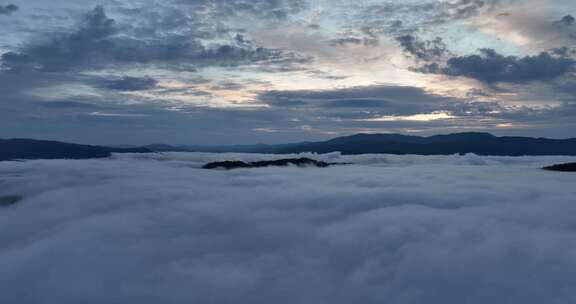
[259, 85, 574, 132]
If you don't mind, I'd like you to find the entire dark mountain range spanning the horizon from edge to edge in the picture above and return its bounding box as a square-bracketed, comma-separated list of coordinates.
[0, 133, 576, 161]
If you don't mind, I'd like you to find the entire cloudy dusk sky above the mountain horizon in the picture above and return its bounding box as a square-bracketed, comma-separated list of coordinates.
[0, 0, 576, 144]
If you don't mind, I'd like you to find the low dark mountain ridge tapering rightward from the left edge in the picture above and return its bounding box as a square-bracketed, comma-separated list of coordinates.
[0, 139, 152, 161]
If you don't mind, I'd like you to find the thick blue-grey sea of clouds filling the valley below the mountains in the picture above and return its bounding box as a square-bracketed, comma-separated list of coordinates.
[0, 153, 576, 304]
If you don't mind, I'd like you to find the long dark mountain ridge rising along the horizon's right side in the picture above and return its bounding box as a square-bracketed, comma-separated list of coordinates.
[147, 132, 576, 156]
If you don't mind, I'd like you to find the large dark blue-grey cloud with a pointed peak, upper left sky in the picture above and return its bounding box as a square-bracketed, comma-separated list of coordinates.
[2, 6, 310, 72]
